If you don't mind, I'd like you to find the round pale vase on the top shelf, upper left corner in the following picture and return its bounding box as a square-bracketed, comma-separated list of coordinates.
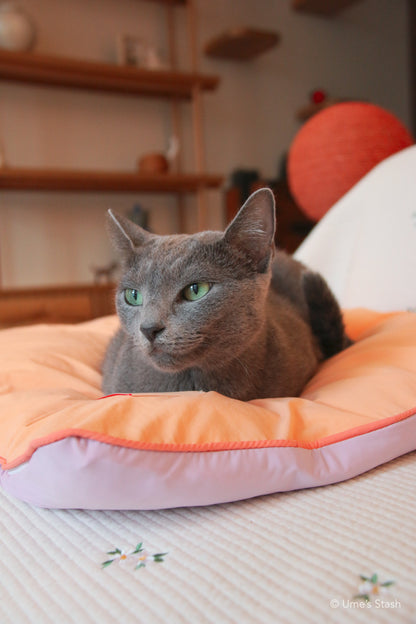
[0, 2, 36, 52]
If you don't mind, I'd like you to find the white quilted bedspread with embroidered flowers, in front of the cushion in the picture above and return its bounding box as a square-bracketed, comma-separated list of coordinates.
[0, 453, 416, 624]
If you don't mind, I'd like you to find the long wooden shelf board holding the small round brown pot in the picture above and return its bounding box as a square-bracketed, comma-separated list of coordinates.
[0, 167, 223, 193]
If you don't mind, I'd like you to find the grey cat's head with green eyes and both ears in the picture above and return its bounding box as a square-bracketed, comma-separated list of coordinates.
[108, 189, 275, 372]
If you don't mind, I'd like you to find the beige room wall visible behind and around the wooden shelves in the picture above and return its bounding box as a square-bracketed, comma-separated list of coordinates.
[0, 0, 410, 287]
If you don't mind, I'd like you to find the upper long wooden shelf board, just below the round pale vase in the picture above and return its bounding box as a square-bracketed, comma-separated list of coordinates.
[0, 50, 219, 98]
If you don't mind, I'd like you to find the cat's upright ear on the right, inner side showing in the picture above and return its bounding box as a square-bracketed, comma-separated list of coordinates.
[224, 188, 276, 273]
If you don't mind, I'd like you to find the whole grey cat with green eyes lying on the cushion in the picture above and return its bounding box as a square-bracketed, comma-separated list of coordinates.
[103, 189, 348, 401]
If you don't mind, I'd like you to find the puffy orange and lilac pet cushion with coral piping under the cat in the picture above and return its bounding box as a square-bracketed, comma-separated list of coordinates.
[0, 310, 416, 509]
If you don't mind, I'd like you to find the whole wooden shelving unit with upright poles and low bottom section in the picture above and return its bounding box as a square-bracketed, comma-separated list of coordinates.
[0, 0, 223, 326]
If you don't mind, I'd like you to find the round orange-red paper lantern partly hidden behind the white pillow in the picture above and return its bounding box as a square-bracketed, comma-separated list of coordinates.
[288, 102, 414, 221]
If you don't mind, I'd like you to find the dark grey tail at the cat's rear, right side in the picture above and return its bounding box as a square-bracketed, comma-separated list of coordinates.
[302, 270, 352, 358]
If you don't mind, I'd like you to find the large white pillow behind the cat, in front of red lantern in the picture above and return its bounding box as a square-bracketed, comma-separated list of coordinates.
[295, 145, 416, 312]
